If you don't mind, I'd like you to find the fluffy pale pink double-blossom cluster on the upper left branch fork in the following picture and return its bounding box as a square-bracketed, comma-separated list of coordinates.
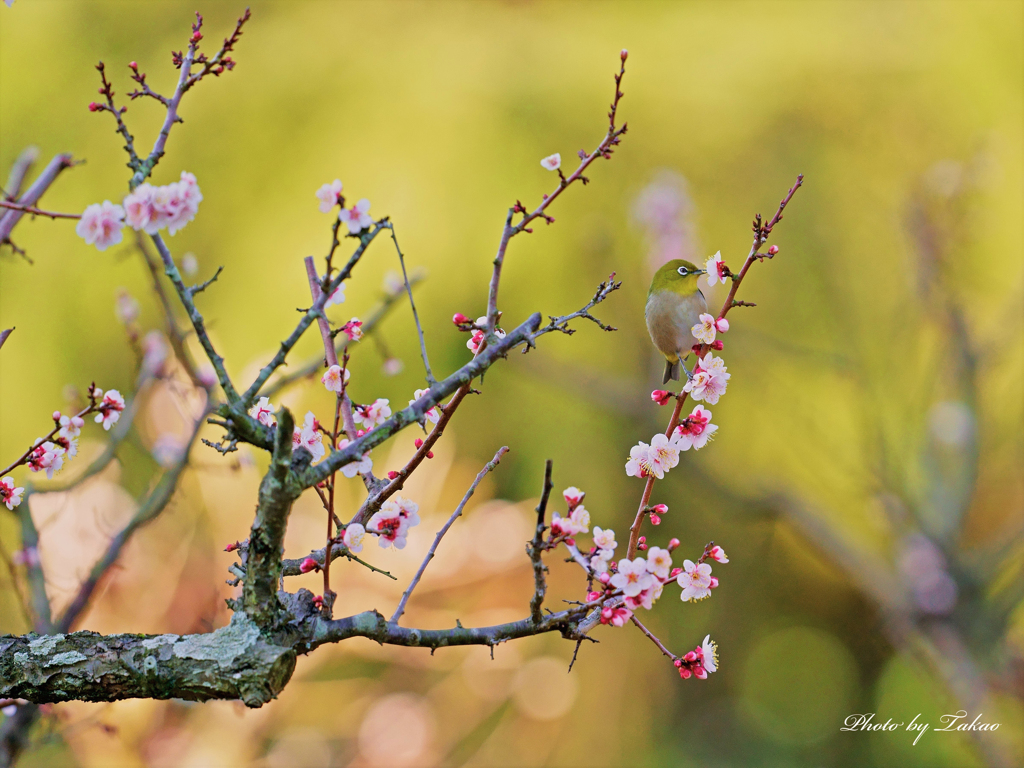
[75, 171, 203, 251]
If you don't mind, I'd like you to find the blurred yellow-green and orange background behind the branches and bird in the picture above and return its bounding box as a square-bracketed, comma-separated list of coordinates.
[0, 0, 1024, 768]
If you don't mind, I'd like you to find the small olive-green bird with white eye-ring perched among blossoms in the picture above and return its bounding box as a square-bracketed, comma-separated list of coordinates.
[644, 259, 708, 384]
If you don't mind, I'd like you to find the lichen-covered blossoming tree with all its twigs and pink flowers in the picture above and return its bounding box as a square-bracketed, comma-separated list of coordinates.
[0, 11, 799, 754]
